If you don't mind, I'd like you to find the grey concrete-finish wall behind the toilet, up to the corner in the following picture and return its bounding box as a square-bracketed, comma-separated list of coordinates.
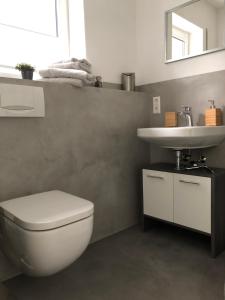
[0, 78, 150, 240]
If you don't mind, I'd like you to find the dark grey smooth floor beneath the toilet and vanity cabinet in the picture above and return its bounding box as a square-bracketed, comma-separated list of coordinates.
[5, 226, 225, 300]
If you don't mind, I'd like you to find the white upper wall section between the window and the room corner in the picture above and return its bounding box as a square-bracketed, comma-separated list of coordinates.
[84, 0, 136, 83]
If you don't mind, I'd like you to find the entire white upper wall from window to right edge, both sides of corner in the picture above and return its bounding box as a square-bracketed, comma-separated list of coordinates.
[84, 0, 225, 84]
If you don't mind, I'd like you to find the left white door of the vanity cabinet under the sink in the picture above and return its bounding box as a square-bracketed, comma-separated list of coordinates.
[143, 170, 173, 222]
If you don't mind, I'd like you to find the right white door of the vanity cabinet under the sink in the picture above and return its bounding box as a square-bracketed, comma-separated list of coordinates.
[174, 174, 211, 233]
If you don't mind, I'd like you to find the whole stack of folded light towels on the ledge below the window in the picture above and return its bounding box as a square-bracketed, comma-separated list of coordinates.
[39, 58, 96, 87]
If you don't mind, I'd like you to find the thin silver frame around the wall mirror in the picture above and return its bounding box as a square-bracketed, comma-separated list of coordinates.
[164, 0, 225, 64]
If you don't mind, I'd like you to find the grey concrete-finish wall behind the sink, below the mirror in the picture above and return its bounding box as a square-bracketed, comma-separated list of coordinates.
[139, 71, 225, 168]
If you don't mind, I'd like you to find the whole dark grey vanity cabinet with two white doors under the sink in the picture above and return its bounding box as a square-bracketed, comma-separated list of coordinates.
[143, 164, 225, 257]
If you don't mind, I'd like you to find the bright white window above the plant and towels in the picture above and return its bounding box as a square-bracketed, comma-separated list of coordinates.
[0, 0, 86, 73]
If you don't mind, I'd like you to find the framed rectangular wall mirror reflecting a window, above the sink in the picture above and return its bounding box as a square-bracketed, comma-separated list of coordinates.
[165, 0, 225, 63]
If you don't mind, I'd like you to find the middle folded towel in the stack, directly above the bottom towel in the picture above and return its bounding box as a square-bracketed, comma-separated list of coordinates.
[39, 68, 96, 84]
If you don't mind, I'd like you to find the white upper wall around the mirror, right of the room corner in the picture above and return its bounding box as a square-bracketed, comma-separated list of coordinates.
[136, 0, 225, 84]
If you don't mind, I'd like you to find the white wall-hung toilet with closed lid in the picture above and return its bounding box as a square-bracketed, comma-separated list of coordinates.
[0, 191, 94, 276]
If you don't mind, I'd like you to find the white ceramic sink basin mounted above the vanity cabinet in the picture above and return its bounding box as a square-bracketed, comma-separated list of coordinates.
[137, 126, 225, 150]
